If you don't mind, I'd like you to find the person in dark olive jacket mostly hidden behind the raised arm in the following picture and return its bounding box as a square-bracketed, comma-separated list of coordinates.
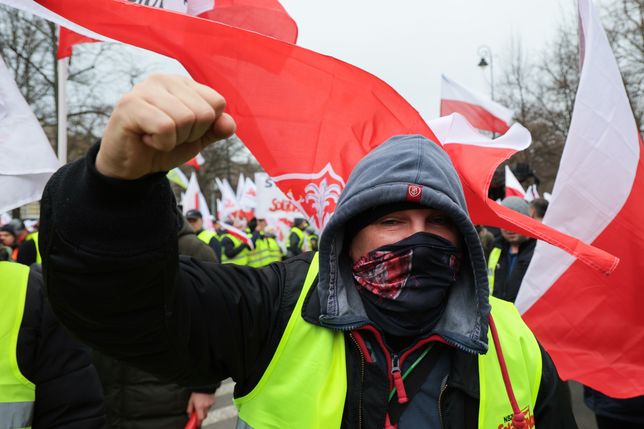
[92, 211, 219, 429]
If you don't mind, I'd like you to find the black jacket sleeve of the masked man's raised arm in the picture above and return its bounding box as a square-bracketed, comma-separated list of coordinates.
[41, 146, 308, 392]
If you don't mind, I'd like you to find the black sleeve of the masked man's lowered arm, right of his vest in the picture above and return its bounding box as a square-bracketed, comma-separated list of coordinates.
[534, 344, 577, 428]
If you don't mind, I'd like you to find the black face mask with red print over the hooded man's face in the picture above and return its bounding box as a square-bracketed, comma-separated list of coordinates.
[353, 232, 460, 336]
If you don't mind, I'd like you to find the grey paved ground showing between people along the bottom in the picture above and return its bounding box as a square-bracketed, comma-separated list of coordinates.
[202, 380, 597, 429]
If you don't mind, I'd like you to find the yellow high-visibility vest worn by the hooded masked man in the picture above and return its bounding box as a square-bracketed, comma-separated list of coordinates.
[234, 253, 542, 429]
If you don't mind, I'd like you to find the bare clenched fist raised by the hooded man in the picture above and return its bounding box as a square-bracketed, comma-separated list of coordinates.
[96, 75, 235, 179]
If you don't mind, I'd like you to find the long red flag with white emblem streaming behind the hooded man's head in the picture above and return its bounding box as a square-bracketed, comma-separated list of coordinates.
[5, 0, 616, 272]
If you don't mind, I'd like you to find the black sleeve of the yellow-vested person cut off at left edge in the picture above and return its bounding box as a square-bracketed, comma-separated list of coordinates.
[18, 270, 106, 429]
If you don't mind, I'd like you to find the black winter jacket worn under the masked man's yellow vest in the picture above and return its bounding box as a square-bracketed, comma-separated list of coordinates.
[41, 142, 576, 429]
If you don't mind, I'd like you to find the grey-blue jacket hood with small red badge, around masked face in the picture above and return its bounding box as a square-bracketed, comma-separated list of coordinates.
[317, 135, 490, 353]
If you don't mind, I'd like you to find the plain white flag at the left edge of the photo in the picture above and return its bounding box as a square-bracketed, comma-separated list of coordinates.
[0, 58, 60, 213]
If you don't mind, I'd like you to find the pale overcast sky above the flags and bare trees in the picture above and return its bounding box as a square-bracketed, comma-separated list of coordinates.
[115, 0, 597, 120]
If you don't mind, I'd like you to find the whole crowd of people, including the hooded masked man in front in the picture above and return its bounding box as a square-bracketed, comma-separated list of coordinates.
[0, 76, 643, 429]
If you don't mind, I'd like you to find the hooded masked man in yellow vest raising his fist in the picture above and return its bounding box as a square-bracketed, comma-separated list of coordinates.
[41, 76, 576, 429]
